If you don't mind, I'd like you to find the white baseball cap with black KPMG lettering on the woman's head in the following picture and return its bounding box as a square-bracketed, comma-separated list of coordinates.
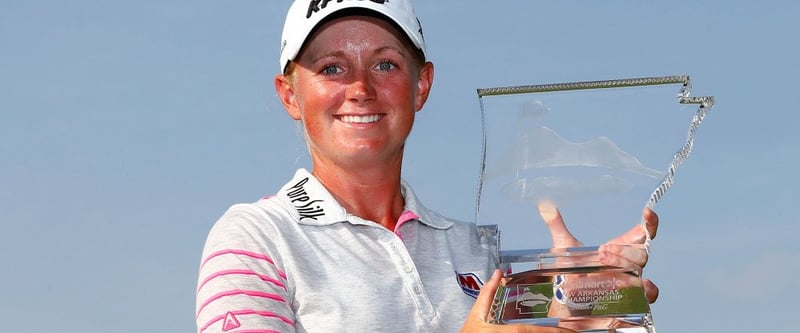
[280, 0, 425, 72]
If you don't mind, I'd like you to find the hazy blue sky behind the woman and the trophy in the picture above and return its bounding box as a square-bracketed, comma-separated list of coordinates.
[0, 0, 800, 333]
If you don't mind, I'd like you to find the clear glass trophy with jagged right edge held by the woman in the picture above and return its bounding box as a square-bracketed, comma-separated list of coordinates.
[476, 76, 714, 333]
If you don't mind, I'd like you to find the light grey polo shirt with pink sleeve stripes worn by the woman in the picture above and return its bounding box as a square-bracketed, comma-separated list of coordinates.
[196, 169, 496, 333]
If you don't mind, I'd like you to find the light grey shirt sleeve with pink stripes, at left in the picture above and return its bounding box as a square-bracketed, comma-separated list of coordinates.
[195, 205, 295, 333]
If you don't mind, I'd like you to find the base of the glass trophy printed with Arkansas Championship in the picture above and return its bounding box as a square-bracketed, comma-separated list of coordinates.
[488, 247, 655, 333]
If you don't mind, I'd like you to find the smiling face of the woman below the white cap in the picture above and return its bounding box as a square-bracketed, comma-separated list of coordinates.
[276, 16, 433, 170]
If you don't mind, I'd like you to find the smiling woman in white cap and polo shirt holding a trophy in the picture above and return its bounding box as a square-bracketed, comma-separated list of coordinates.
[197, 0, 657, 332]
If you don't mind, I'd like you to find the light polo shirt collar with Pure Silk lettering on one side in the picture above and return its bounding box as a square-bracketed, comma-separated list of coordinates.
[277, 168, 453, 229]
